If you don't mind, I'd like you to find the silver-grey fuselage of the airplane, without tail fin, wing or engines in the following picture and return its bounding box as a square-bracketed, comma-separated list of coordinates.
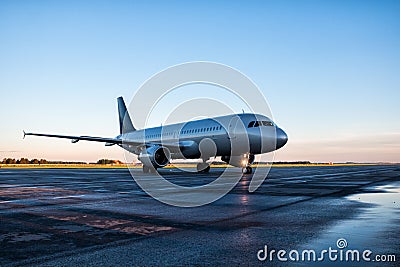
[120, 114, 287, 158]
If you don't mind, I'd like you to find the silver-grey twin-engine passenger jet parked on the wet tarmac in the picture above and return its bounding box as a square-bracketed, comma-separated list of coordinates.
[23, 97, 288, 174]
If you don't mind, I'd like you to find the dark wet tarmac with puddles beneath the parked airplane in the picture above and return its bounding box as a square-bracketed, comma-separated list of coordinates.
[0, 165, 400, 266]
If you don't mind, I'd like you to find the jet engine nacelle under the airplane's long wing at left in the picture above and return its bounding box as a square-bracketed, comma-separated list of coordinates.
[138, 146, 171, 168]
